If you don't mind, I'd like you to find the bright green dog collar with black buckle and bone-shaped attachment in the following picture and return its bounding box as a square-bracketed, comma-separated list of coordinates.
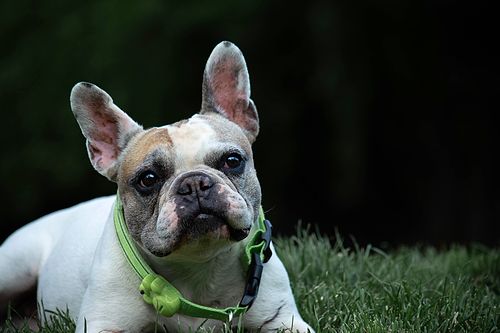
[114, 194, 272, 321]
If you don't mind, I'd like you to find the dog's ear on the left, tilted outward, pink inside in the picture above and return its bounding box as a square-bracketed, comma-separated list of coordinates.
[70, 82, 142, 181]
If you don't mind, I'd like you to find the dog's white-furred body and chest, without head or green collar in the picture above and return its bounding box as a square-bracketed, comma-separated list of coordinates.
[0, 197, 312, 333]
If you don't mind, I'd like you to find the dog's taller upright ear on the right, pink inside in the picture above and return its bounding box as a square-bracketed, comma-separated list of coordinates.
[201, 42, 259, 143]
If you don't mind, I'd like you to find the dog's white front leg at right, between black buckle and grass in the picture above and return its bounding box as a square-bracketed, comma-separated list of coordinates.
[244, 244, 314, 333]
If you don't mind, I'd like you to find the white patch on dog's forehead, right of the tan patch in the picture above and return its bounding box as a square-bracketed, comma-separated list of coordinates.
[167, 115, 218, 169]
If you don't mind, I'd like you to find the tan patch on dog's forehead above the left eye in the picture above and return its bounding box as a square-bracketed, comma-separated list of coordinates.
[122, 127, 172, 176]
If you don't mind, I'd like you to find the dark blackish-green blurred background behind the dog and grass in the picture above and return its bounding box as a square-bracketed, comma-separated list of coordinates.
[0, 0, 500, 246]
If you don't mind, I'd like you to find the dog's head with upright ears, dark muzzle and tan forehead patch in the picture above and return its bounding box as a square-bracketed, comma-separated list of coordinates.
[71, 42, 261, 257]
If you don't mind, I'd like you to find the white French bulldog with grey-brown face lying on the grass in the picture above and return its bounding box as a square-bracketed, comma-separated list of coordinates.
[0, 41, 314, 333]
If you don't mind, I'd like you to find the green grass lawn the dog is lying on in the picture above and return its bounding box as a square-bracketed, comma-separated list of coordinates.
[0, 230, 500, 333]
